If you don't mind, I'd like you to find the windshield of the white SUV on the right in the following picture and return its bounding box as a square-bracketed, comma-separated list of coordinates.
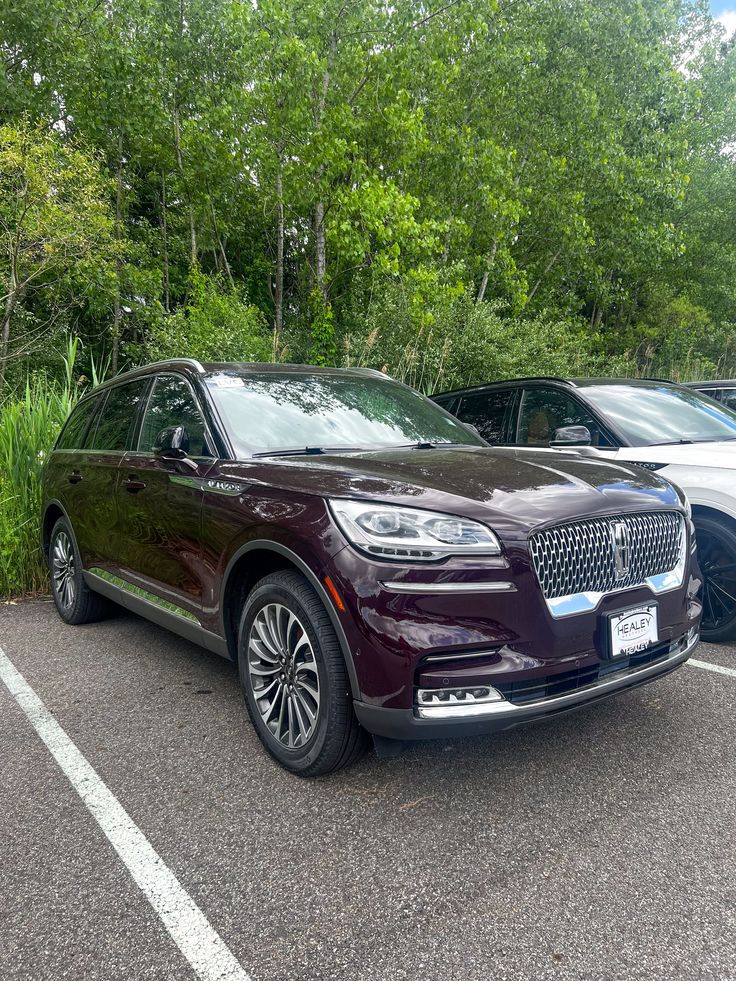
[583, 383, 736, 446]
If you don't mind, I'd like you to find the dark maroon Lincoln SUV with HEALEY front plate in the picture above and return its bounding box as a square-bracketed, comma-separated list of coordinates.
[43, 360, 700, 775]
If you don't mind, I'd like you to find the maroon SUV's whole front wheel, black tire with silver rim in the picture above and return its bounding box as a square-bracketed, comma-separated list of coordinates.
[238, 571, 370, 777]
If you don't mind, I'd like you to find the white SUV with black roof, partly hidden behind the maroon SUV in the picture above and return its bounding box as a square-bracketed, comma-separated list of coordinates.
[434, 378, 736, 641]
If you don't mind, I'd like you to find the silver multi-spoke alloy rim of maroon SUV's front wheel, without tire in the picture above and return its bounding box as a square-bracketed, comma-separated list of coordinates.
[248, 603, 320, 749]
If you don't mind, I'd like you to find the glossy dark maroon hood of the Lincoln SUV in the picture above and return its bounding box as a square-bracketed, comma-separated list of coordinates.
[221, 447, 680, 538]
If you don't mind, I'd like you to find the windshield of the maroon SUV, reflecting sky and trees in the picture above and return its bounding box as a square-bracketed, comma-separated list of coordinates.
[207, 371, 486, 456]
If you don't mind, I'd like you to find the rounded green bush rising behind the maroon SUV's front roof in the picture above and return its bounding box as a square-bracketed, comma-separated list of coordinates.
[141, 270, 272, 361]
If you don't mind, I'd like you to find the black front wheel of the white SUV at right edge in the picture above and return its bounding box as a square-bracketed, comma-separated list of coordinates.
[693, 514, 736, 644]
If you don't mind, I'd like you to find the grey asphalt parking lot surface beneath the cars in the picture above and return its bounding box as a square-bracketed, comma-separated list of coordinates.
[0, 601, 736, 981]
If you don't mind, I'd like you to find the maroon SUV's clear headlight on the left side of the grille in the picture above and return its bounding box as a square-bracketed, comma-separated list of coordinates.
[329, 500, 501, 562]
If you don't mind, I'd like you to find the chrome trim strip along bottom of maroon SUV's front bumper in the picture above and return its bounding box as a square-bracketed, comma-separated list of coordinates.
[414, 634, 700, 721]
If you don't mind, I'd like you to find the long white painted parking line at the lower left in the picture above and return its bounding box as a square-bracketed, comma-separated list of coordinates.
[0, 648, 250, 981]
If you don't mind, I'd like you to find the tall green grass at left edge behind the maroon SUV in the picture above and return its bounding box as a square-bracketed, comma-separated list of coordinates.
[0, 340, 79, 599]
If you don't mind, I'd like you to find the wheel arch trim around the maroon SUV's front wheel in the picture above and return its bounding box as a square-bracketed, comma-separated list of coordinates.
[220, 539, 360, 700]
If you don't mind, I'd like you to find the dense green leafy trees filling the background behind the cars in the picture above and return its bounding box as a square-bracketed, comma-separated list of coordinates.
[0, 0, 736, 388]
